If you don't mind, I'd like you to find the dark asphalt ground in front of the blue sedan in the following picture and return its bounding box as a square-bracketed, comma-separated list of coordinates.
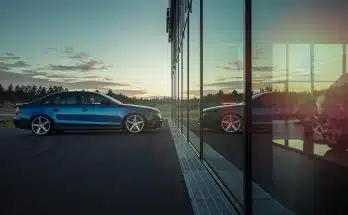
[0, 121, 193, 215]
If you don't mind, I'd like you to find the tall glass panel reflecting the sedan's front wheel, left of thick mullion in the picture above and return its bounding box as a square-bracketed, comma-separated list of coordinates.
[201, 0, 245, 208]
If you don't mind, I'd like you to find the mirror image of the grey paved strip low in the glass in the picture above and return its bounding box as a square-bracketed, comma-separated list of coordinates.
[178, 122, 294, 215]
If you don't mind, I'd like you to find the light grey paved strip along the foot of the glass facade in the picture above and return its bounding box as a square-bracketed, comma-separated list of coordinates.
[168, 120, 237, 215]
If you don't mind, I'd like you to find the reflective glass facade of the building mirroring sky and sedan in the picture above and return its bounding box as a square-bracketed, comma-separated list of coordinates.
[168, 0, 348, 215]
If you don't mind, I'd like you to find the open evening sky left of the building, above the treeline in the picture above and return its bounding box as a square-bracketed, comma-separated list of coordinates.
[0, 0, 170, 95]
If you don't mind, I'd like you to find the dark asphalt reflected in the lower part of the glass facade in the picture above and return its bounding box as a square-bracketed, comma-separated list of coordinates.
[182, 119, 348, 215]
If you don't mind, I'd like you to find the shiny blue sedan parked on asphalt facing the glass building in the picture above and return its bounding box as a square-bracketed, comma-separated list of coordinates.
[13, 91, 163, 136]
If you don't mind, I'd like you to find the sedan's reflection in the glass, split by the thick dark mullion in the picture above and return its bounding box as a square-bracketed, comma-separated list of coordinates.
[202, 92, 305, 133]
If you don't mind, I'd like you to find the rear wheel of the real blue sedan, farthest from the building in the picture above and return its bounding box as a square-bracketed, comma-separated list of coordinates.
[30, 115, 53, 136]
